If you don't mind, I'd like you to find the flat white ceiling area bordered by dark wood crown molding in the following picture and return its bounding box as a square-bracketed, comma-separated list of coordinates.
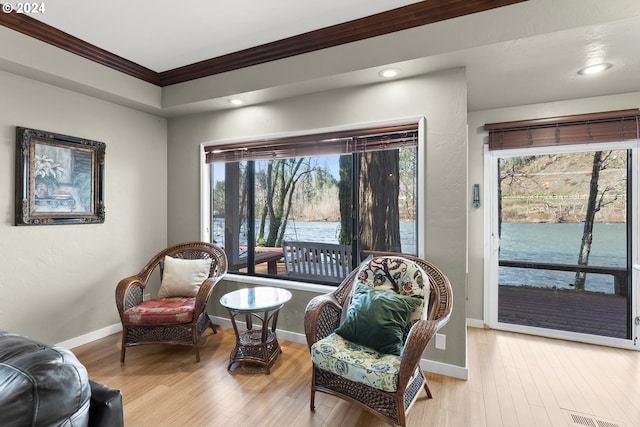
[31, 0, 424, 72]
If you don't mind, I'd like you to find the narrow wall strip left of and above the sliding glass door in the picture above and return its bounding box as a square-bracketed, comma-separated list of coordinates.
[467, 92, 640, 324]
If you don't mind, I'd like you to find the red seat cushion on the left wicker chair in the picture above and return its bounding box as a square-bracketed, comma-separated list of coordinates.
[124, 297, 196, 325]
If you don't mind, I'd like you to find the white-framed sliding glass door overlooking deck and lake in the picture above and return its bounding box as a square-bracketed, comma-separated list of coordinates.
[485, 143, 638, 346]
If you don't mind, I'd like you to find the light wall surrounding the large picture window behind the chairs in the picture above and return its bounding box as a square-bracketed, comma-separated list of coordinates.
[168, 69, 467, 367]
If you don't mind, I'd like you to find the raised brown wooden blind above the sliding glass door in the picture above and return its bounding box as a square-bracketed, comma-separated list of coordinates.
[484, 109, 640, 150]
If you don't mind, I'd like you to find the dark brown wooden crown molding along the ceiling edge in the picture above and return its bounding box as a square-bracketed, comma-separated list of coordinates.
[0, 0, 527, 87]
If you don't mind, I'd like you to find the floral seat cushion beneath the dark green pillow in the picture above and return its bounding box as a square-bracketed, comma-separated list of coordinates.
[311, 333, 400, 392]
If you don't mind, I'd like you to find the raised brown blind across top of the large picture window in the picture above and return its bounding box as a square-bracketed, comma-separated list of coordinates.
[204, 123, 418, 163]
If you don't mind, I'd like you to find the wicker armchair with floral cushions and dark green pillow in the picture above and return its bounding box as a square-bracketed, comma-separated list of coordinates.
[304, 255, 452, 426]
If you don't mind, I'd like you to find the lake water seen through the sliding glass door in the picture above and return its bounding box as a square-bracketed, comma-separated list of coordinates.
[499, 223, 627, 294]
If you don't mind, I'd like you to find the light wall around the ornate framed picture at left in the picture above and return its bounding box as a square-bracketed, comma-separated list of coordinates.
[0, 71, 167, 343]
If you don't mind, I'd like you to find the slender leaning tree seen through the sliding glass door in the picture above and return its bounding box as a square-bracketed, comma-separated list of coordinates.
[575, 151, 617, 290]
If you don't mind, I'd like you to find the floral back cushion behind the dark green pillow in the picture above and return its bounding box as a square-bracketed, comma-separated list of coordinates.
[354, 256, 431, 324]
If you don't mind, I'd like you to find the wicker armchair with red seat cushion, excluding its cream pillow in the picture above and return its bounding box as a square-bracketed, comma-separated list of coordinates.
[116, 242, 227, 362]
